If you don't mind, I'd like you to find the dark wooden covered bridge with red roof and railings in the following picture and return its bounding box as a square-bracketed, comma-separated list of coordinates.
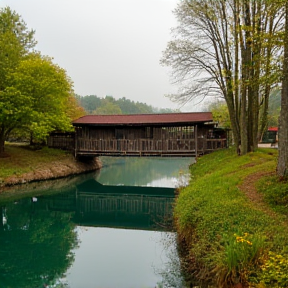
[48, 112, 227, 156]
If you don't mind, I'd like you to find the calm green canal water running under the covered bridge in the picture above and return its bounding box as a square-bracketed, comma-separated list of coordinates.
[0, 157, 194, 288]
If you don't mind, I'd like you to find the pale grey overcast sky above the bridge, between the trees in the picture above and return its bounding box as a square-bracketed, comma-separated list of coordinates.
[0, 0, 194, 108]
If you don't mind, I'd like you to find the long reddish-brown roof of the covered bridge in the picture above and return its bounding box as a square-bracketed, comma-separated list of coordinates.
[73, 112, 213, 126]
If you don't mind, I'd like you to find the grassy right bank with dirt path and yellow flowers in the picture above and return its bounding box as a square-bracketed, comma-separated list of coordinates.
[175, 149, 288, 288]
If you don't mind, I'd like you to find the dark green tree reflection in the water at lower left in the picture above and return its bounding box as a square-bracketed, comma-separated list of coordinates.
[0, 199, 77, 288]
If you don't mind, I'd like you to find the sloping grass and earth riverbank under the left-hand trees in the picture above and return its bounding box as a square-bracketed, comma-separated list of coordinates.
[0, 144, 101, 192]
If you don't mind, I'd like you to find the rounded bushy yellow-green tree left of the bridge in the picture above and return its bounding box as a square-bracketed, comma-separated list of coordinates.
[0, 54, 72, 155]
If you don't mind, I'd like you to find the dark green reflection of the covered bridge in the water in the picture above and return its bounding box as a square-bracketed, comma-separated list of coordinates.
[38, 179, 175, 231]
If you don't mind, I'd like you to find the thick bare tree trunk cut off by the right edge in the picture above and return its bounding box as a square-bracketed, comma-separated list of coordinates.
[277, 0, 288, 178]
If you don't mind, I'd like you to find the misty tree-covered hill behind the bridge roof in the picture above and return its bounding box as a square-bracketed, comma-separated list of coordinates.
[76, 95, 180, 115]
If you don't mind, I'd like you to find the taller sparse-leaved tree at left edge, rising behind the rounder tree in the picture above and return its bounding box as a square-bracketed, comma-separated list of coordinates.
[0, 7, 36, 155]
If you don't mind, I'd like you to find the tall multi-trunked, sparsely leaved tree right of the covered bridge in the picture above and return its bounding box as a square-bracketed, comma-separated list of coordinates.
[162, 0, 284, 154]
